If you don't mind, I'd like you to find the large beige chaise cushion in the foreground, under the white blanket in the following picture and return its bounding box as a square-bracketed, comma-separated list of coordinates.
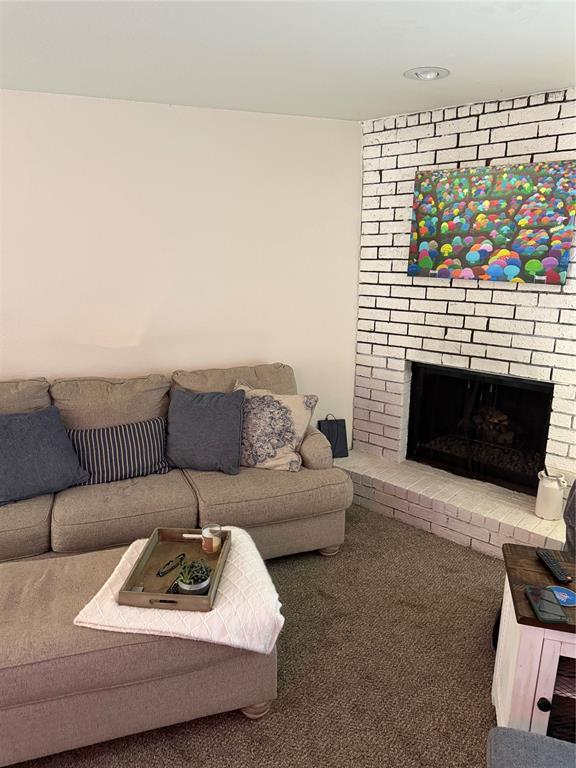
[0, 549, 253, 710]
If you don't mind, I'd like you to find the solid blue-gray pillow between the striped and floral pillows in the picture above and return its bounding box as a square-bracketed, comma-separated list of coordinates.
[166, 389, 245, 475]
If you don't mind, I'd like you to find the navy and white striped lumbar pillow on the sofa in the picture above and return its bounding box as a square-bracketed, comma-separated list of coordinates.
[67, 418, 170, 485]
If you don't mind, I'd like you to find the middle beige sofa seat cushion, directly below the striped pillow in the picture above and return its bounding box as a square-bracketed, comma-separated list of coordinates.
[52, 469, 198, 552]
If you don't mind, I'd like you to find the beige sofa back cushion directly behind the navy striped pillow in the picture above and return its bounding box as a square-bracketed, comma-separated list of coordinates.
[50, 374, 170, 429]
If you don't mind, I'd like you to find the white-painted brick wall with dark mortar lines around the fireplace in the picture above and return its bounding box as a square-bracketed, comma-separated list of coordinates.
[353, 90, 576, 479]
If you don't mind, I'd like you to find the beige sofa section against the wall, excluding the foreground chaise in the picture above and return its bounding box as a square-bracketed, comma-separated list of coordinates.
[0, 363, 352, 561]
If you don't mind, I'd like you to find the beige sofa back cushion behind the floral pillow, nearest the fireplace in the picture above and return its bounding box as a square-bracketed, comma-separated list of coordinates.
[172, 363, 296, 395]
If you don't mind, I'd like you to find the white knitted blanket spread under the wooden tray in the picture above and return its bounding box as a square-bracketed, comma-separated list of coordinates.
[74, 527, 284, 654]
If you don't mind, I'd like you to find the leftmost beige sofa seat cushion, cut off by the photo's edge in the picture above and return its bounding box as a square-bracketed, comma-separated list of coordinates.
[0, 493, 54, 560]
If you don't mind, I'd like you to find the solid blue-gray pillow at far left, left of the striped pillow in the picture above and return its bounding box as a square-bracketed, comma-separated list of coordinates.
[0, 405, 89, 506]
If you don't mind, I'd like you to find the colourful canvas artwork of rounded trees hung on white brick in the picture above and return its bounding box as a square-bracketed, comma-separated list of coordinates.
[408, 160, 576, 284]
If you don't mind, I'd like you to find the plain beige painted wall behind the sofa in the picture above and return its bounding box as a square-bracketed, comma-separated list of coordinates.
[0, 91, 361, 429]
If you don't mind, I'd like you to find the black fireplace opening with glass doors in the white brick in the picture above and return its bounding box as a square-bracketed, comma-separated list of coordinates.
[407, 363, 553, 495]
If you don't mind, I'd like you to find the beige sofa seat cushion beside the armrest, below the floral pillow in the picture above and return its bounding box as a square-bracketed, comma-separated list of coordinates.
[184, 467, 352, 528]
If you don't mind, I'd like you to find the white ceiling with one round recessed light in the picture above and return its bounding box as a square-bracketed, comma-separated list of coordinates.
[0, 0, 576, 120]
